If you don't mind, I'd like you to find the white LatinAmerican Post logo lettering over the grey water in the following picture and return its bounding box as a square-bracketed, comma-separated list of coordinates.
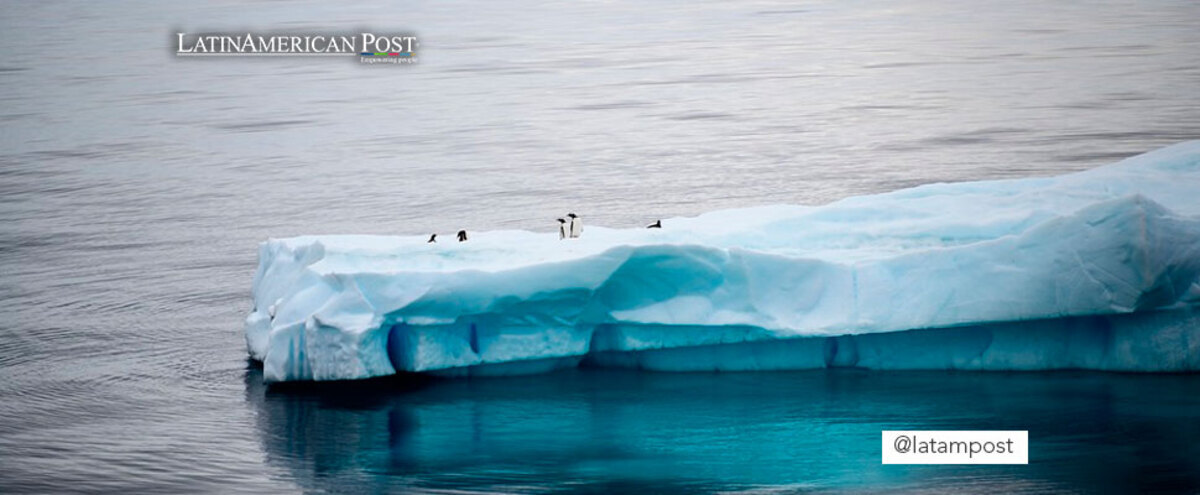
[174, 32, 421, 64]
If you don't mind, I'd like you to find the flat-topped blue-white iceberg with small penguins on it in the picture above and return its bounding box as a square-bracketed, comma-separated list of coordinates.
[245, 141, 1200, 382]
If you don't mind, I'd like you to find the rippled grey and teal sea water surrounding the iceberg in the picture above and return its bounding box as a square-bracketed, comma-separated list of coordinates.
[0, 0, 1200, 493]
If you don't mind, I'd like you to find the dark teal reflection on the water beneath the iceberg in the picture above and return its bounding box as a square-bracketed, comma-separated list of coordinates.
[246, 368, 1200, 493]
